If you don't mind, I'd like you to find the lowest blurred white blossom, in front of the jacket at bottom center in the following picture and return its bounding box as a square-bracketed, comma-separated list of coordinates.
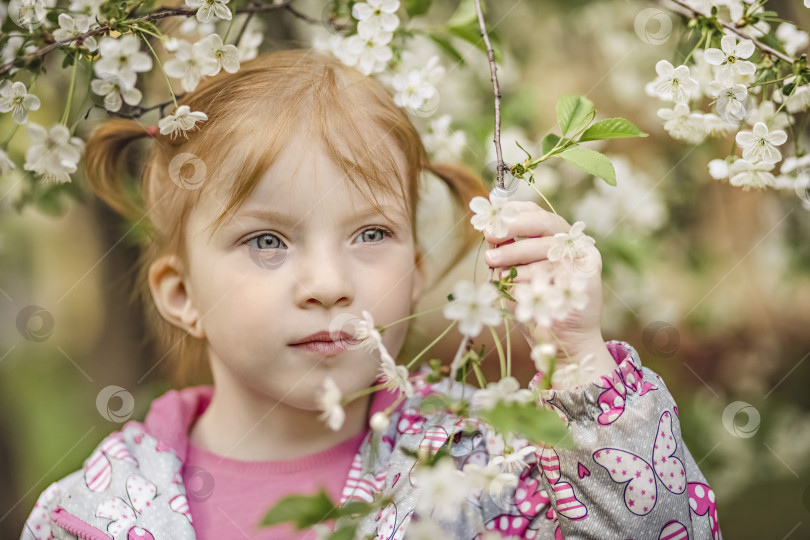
[412, 456, 474, 521]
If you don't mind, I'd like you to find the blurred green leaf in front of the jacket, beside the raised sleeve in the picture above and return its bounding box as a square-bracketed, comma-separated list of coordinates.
[479, 402, 574, 448]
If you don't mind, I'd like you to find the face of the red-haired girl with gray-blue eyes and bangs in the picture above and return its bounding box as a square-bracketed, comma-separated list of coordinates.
[178, 127, 422, 410]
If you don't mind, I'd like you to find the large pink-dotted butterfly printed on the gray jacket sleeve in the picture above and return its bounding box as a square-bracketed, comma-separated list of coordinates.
[593, 411, 686, 516]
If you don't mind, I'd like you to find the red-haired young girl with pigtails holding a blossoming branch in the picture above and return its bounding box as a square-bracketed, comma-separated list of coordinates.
[22, 50, 721, 540]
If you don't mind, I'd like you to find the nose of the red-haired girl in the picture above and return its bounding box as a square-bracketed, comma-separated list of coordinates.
[295, 249, 354, 308]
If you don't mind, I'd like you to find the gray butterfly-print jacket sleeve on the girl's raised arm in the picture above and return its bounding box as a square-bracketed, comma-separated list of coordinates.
[516, 341, 722, 540]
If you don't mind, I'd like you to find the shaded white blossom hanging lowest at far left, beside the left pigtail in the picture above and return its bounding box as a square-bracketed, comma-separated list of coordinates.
[23, 122, 84, 183]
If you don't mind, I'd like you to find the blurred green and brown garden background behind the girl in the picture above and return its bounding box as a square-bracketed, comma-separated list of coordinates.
[0, 0, 810, 539]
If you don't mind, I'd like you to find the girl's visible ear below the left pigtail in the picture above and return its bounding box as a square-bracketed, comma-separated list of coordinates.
[149, 255, 205, 339]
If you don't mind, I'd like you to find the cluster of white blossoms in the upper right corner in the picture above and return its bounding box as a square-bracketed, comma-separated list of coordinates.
[645, 0, 810, 196]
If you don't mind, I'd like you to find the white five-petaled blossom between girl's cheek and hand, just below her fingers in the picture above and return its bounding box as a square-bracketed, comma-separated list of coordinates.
[444, 280, 501, 337]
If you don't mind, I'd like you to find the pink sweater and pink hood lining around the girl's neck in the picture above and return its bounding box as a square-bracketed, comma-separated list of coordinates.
[144, 386, 395, 540]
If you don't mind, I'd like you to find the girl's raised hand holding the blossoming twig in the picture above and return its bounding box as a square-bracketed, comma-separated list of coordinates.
[484, 201, 616, 382]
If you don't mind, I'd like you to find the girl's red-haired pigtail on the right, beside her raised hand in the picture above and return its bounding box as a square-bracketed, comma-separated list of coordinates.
[423, 162, 490, 288]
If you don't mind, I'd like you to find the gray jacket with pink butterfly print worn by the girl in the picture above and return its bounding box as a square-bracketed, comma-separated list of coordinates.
[21, 341, 722, 540]
